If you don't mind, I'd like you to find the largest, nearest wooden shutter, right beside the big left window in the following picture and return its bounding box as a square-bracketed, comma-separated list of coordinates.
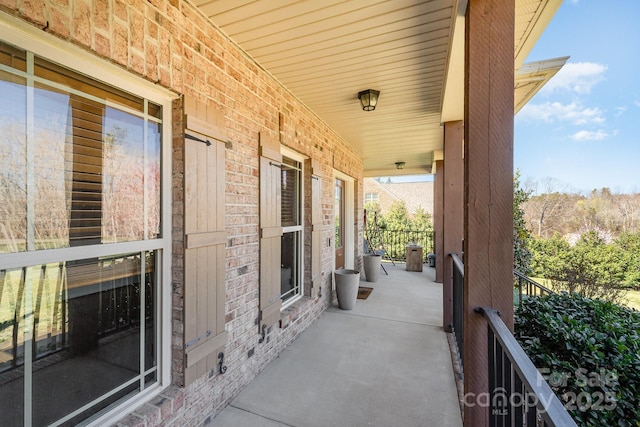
[184, 100, 227, 385]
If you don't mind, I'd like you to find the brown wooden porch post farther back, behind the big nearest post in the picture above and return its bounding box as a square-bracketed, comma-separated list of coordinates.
[442, 121, 464, 332]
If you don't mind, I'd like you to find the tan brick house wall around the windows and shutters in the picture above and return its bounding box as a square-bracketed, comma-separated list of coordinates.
[0, 0, 363, 426]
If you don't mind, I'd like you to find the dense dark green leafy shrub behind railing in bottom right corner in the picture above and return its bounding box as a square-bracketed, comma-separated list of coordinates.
[514, 293, 640, 427]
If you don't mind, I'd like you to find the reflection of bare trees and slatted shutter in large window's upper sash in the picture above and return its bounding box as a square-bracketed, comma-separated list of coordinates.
[0, 46, 162, 253]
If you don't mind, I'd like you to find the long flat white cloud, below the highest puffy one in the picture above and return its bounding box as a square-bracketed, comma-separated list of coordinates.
[518, 102, 605, 126]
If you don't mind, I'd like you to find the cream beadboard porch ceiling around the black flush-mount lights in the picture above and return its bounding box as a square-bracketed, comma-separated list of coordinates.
[193, 0, 561, 176]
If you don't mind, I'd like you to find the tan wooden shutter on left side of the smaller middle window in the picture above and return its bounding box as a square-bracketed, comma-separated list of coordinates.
[260, 134, 282, 330]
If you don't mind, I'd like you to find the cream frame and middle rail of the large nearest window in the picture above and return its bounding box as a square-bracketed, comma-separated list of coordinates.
[0, 12, 178, 426]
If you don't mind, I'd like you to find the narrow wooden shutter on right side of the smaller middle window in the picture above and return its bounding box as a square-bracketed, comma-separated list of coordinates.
[310, 159, 322, 298]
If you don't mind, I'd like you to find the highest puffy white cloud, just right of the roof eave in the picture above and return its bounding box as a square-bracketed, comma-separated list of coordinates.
[541, 62, 607, 94]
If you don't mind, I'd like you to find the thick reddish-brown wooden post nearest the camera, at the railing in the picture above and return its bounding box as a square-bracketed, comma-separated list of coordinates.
[464, 0, 515, 427]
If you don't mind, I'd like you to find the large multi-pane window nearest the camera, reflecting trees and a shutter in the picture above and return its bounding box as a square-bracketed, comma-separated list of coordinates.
[0, 38, 170, 425]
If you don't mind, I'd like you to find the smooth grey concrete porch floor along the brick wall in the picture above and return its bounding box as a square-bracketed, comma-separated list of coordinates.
[209, 263, 462, 427]
